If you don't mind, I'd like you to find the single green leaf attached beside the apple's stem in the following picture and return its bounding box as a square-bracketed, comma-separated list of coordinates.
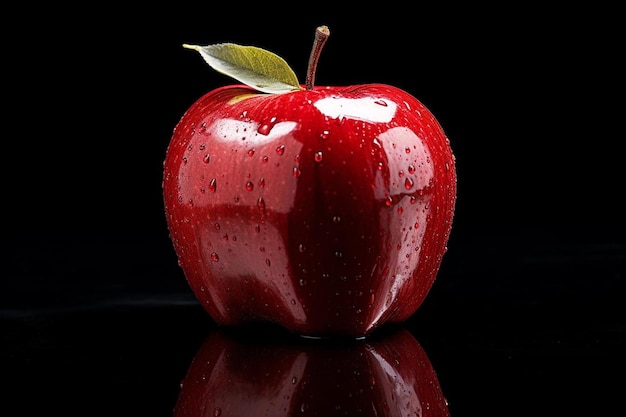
[183, 43, 303, 94]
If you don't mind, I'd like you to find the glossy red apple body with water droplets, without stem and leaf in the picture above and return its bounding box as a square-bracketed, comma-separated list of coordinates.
[163, 84, 457, 337]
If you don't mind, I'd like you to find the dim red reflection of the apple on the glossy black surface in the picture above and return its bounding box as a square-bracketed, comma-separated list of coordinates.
[174, 328, 449, 417]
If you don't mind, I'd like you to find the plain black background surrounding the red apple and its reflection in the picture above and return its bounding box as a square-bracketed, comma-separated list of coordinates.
[0, 2, 626, 416]
